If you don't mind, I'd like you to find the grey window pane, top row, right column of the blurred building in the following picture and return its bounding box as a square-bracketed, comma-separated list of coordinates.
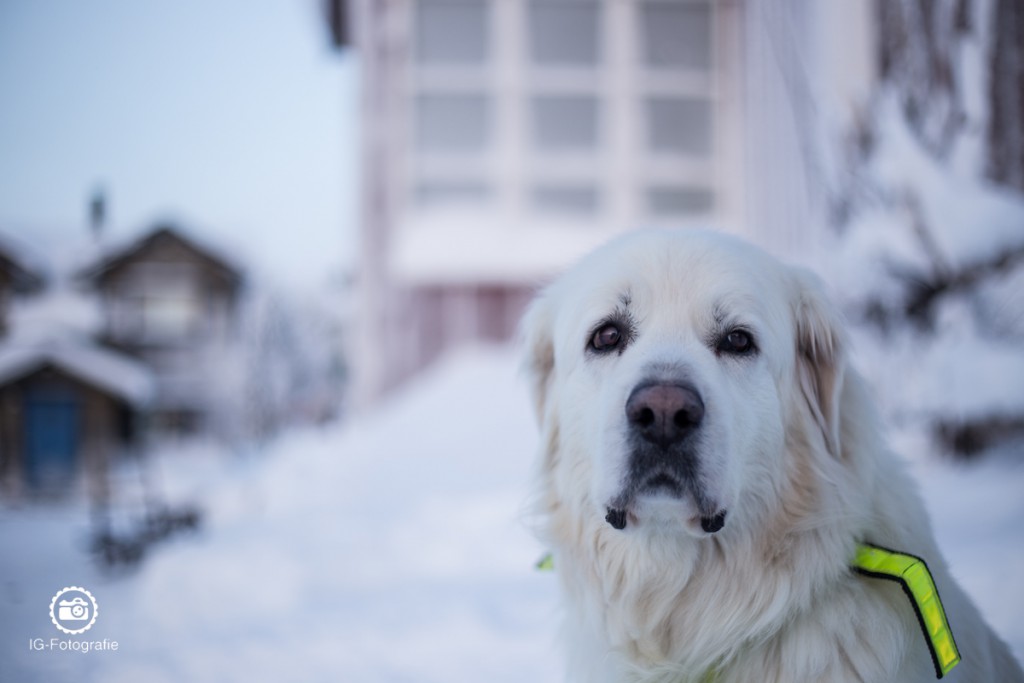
[640, 2, 712, 71]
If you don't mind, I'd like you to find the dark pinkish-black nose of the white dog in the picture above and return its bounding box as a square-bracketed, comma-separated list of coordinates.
[626, 383, 703, 447]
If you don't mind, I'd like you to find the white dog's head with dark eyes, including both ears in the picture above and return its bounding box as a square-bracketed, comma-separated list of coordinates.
[525, 231, 841, 537]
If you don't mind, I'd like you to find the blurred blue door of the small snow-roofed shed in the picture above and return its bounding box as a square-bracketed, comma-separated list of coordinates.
[25, 387, 79, 492]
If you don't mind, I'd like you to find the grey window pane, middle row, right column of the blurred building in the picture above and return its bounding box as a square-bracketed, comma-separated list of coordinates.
[647, 97, 711, 157]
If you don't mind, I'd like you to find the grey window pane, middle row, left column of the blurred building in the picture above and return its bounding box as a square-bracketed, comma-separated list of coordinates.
[416, 94, 489, 154]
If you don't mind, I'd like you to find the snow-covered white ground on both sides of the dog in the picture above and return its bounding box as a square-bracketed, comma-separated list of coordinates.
[0, 349, 1024, 683]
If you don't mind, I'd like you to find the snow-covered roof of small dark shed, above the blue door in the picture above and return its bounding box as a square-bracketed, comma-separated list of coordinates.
[0, 339, 156, 405]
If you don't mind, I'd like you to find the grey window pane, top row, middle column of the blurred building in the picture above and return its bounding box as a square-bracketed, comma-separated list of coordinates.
[528, 0, 601, 66]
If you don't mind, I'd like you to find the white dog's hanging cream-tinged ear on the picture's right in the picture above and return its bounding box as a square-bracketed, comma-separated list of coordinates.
[794, 268, 847, 458]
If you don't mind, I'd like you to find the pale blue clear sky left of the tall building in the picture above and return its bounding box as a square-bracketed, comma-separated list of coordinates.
[0, 0, 357, 286]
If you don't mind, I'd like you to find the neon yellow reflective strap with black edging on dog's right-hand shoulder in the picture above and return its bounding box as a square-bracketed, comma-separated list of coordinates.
[853, 544, 961, 678]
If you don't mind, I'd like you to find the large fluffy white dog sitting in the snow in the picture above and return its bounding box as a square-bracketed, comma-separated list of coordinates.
[523, 231, 1024, 683]
